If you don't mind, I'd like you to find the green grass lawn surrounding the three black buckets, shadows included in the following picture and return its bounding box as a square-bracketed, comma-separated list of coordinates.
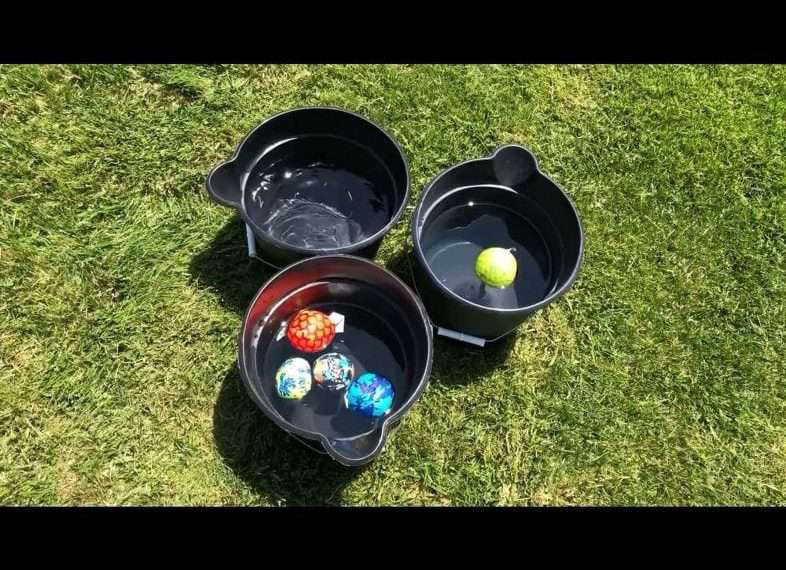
[0, 66, 786, 505]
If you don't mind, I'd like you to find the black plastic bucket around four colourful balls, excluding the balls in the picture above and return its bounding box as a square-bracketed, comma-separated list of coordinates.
[238, 255, 433, 466]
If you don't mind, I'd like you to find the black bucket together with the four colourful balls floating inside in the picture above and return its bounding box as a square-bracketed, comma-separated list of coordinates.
[238, 255, 433, 466]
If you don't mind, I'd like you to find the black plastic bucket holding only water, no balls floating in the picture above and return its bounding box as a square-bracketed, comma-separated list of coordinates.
[202, 107, 409, 268]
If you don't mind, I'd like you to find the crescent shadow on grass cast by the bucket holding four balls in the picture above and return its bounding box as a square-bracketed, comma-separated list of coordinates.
[213, 367, 365, 506]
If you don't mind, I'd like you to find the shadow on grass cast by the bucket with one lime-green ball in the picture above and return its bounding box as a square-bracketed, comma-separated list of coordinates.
[385, 244, 516, 386]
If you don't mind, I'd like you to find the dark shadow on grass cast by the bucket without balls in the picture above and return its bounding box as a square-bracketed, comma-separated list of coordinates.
[189, 216, 275, 315]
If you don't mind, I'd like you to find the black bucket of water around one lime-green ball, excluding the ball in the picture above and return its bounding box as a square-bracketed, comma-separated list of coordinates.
[411, 145, 584, 341]
